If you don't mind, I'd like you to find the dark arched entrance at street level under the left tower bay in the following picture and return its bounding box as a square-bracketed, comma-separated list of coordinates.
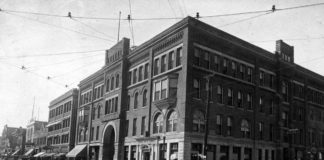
[102, 125, 115, 160]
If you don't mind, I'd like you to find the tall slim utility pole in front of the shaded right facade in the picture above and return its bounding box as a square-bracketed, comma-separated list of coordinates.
[203, 74, 214, 159]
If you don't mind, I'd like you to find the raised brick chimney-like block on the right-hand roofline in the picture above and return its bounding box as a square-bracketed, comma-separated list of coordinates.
[276, 40, 294, 63]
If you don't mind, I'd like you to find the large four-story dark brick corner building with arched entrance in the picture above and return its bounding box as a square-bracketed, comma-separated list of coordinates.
[73, 17, 324, 160]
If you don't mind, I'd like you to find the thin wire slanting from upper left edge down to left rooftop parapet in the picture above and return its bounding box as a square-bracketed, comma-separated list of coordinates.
[0, 11, 114, 42]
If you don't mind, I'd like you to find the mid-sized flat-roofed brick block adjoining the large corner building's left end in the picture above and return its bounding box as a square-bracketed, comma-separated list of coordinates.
[47, 89, 79, 154]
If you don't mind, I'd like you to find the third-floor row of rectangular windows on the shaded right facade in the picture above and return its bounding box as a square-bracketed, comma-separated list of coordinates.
[192, 78, 275, 114]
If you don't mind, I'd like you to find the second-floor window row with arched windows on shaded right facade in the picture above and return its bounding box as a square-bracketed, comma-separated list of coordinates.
[192, 110, 275, 141]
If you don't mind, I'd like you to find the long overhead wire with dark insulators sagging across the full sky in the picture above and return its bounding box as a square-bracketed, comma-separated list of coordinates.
[1, 3, 324, 21]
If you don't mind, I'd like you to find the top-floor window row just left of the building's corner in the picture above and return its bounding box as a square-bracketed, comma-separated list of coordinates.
[153, 46, 183, 76]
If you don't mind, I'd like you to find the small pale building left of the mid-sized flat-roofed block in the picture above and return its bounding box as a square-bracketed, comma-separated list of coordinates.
[25, 118, 47, 155]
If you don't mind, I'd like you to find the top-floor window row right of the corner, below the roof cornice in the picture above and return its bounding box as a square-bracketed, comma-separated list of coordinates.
[193, 46, 275, 89]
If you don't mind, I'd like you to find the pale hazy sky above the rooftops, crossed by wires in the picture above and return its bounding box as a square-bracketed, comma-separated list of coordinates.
[0, 0, 324, 133]
